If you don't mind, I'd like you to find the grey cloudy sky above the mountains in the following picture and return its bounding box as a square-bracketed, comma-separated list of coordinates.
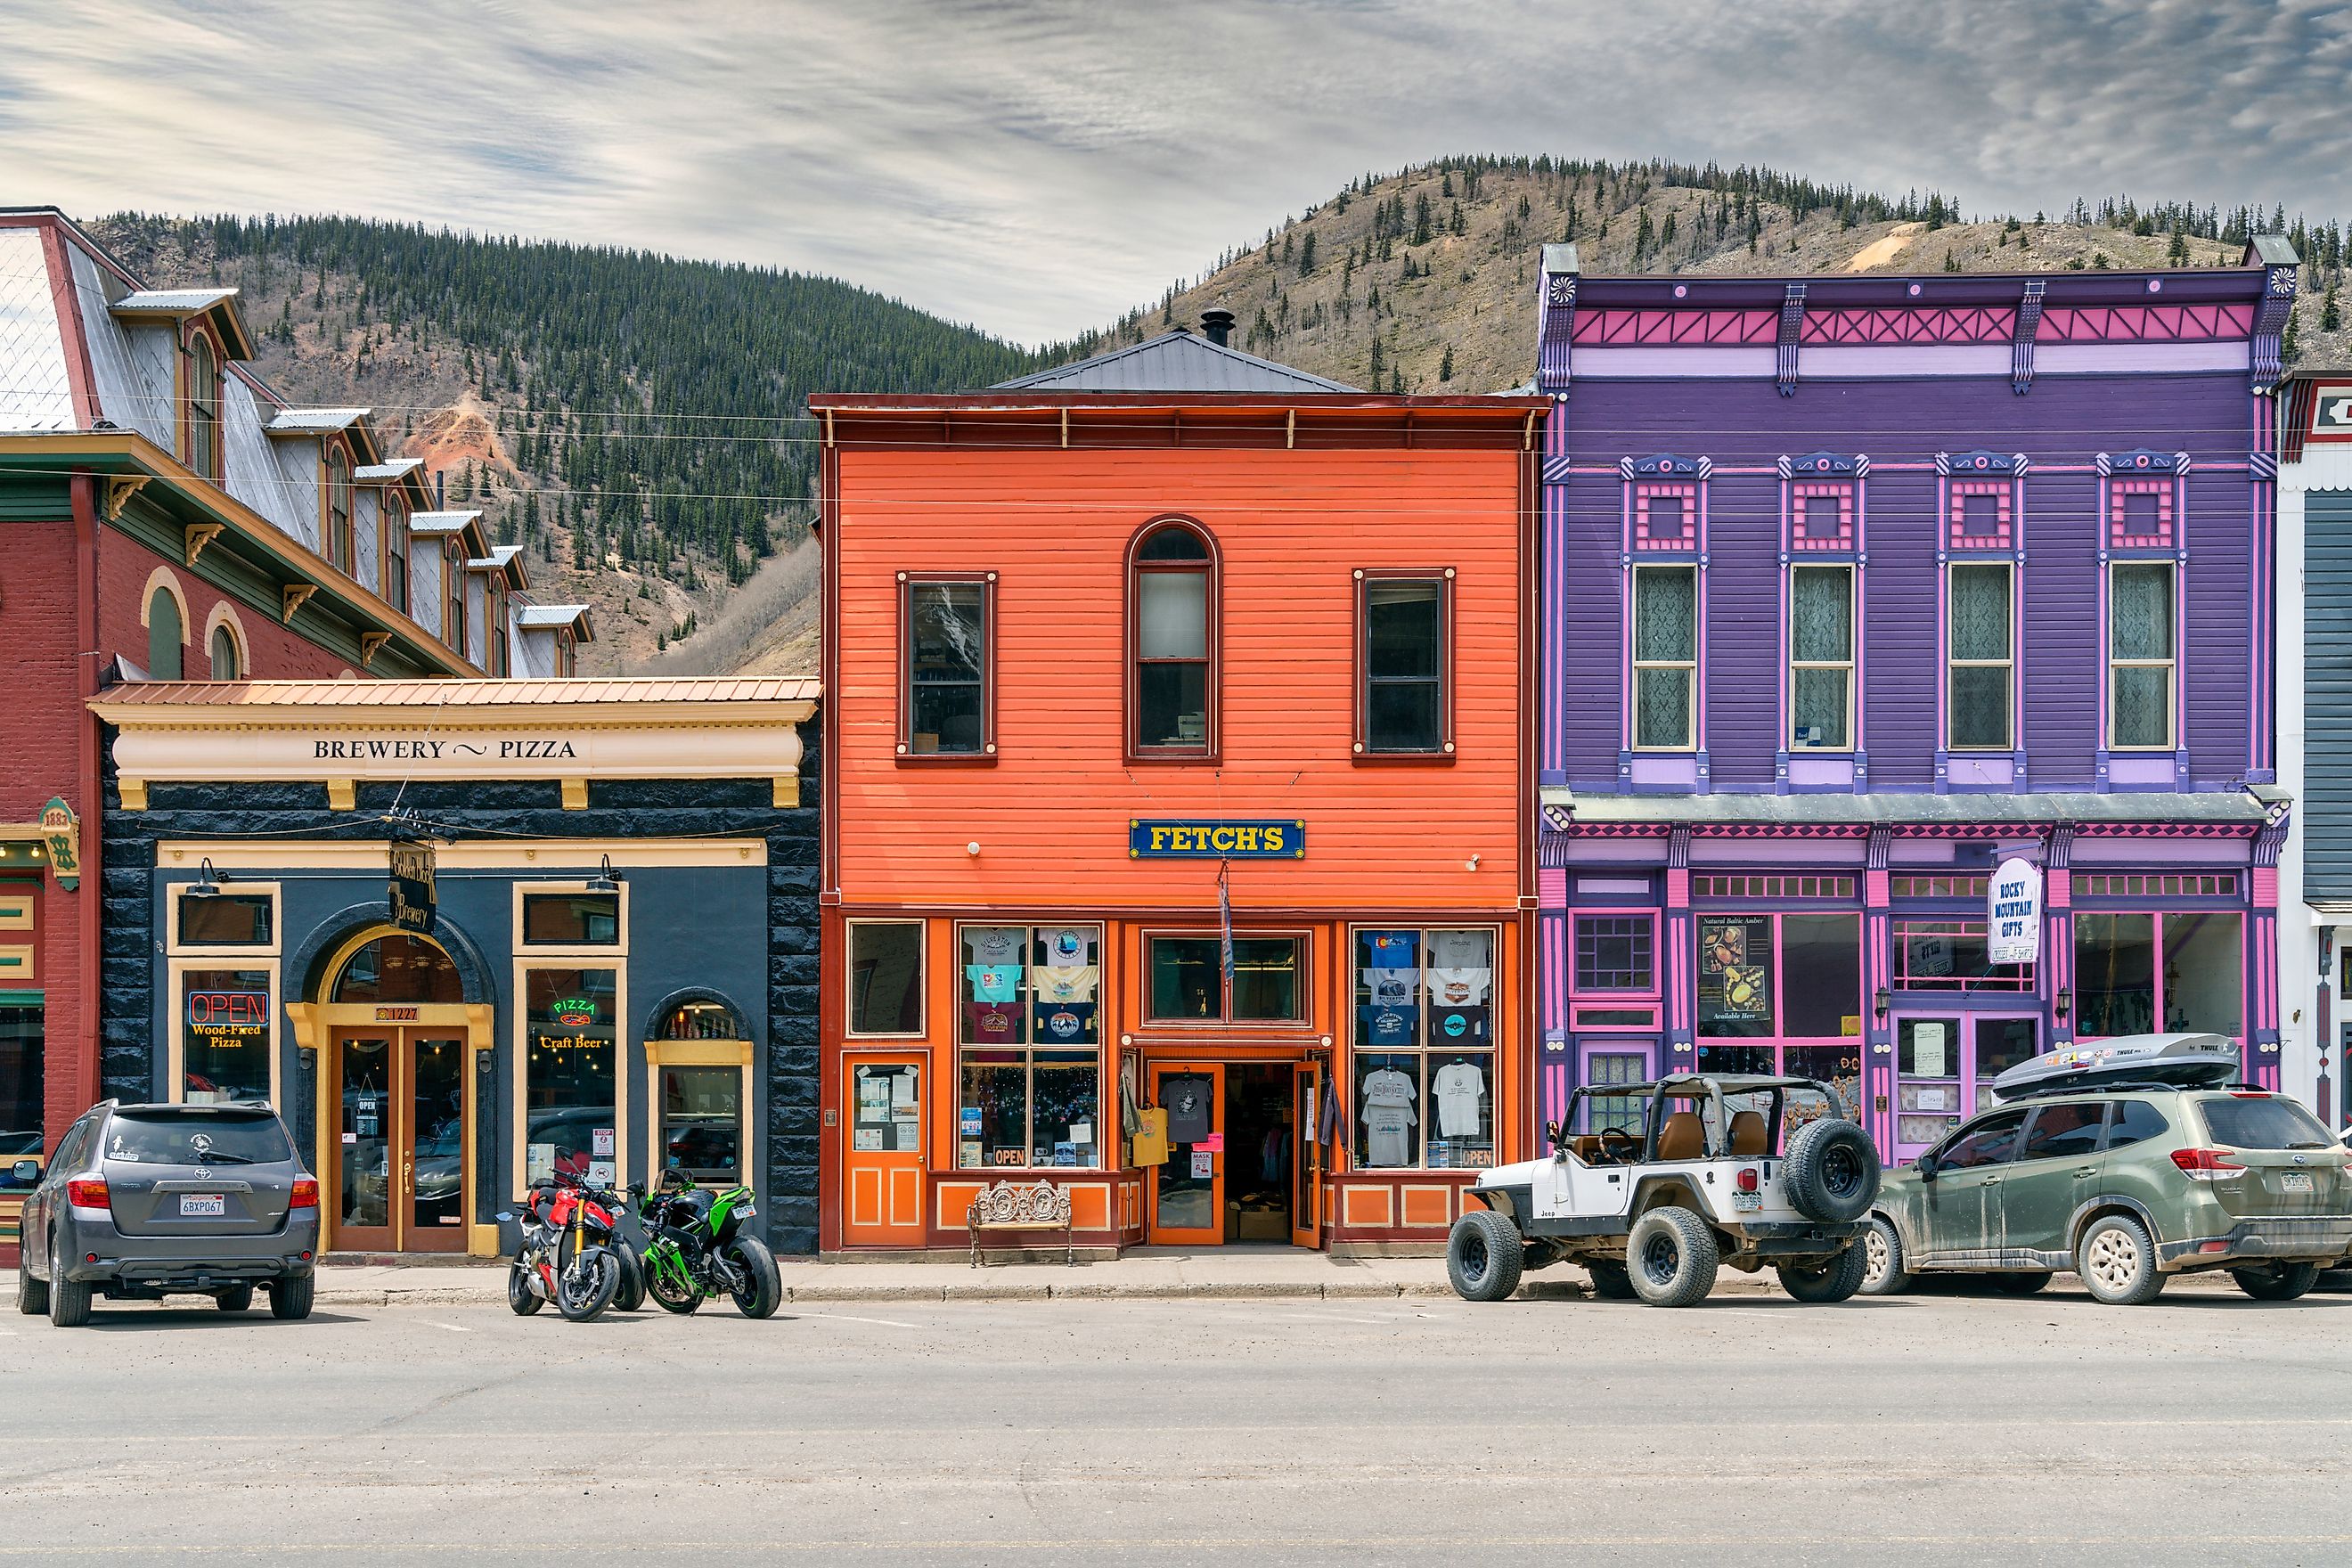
[0, 0, 2352, 341]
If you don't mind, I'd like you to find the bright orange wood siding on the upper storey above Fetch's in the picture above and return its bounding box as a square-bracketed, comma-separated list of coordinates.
[828, 446, 1522, 912]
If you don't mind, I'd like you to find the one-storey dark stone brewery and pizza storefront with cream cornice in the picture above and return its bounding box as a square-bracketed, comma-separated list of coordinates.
[96, 682, 819, 1253]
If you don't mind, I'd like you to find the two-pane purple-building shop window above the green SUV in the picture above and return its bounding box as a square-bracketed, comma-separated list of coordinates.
[2072, 910, 2246, 1041]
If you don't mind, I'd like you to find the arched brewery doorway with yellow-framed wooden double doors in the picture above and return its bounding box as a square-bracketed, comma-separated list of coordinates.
[317, 928, 475, 1253]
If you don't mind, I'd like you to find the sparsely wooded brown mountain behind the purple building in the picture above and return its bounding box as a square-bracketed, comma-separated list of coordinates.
[1089, 158, 2352, 393]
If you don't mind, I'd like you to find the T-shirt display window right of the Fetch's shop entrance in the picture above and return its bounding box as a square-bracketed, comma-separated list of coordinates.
[1352, 927, 1499, 1171]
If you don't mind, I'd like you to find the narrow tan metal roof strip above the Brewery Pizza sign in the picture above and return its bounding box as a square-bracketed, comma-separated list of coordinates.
[92, 674, 821, 707]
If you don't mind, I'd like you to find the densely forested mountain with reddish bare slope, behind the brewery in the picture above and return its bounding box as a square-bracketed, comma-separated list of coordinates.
[89, 214, 1044, 673]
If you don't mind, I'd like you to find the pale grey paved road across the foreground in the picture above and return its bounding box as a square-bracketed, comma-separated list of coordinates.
[0, 1288, 2352, 1568]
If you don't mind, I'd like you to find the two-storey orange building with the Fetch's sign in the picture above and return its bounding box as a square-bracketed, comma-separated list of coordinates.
[812, 313, 1543, 1251]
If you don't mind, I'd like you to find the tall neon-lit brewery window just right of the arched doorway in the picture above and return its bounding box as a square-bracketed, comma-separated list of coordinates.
[522, 968, 618, 1185]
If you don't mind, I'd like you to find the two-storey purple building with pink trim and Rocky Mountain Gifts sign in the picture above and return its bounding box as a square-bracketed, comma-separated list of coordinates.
[1536, 240, 2296, 1159]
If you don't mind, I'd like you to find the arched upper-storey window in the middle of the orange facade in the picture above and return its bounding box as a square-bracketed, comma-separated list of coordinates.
[1127, 522, 1216, 757]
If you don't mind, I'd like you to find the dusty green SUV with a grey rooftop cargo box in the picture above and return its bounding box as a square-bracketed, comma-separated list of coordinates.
[1863, 1034, 2352, 1304]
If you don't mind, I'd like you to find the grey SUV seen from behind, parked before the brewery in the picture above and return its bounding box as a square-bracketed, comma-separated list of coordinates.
[14, 1100, 317, 1328]
